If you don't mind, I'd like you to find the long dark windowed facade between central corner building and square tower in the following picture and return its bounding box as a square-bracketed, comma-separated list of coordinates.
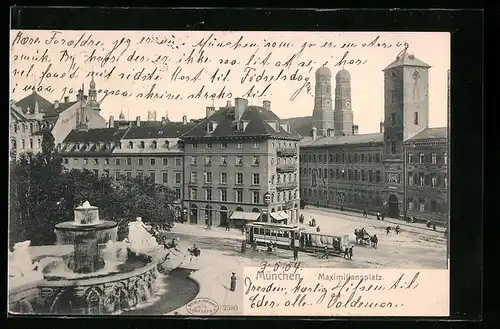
[300, 144, 385, 211]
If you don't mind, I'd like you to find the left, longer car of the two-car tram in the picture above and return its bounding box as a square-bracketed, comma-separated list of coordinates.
[245, 222, 304, 249]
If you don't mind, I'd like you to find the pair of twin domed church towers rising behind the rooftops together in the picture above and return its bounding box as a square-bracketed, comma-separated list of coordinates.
[312, 67, 357, 136]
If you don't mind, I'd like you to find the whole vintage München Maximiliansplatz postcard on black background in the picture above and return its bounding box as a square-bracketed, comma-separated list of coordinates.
[8, 30, 450, 317]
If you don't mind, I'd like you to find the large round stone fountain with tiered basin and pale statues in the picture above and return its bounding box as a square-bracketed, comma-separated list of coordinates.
[9, 202, 168, 314]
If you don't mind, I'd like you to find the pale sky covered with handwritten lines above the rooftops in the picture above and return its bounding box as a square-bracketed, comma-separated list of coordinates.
[10, 30, 450, 133]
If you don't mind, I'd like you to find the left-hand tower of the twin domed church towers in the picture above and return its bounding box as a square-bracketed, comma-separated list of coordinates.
[312, 66, 334, 136]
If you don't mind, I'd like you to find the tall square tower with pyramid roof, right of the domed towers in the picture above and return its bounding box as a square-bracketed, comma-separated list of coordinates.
[383, 49, 430, 218]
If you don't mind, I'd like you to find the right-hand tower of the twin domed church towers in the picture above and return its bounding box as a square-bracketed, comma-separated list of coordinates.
[334, 69, 353, 136]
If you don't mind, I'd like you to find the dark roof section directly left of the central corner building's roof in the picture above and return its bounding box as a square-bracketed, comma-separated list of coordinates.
[123, 122, 195, 139]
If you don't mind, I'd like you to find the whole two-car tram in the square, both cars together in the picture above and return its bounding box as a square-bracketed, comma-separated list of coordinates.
[245, 222, 349, 254]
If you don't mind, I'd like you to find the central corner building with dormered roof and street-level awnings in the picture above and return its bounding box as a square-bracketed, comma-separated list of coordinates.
[182, 98, 302, 226]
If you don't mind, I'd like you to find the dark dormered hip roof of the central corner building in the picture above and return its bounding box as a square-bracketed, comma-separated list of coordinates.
[182, 105, 302, 140]
